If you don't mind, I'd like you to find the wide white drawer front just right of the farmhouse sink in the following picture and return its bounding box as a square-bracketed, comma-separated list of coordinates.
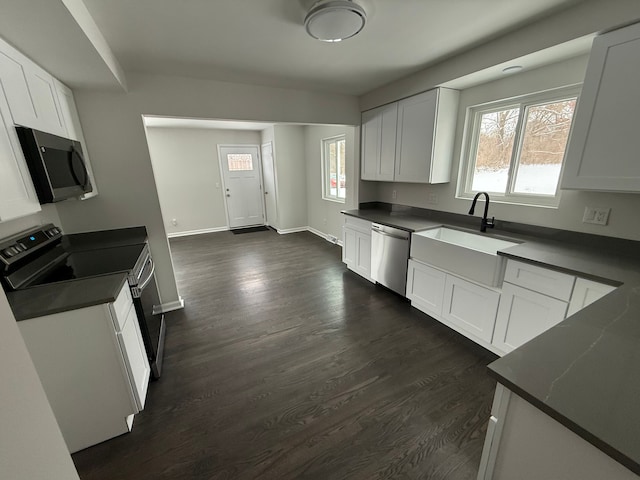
[504, 260, 576, 302]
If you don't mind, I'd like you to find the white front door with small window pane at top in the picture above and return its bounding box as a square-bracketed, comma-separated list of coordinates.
[218, 145, 264, 229]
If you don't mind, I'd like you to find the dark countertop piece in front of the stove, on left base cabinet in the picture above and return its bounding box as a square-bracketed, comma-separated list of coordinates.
[7, 272, 127, 321]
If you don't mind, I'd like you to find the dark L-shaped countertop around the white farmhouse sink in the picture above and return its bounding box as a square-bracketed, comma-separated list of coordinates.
[343, 209, 640, 474]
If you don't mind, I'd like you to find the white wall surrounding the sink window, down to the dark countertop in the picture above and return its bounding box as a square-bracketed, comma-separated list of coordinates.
[369, 56, 640, 240]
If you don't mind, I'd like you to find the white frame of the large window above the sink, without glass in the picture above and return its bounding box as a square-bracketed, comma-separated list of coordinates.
[456, 84, 582, 208]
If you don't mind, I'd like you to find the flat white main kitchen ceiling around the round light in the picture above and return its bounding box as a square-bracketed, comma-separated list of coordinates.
[79, 0, 577, 95]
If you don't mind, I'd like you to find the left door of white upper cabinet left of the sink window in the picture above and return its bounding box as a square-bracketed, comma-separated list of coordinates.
[360, 103, 398, 181]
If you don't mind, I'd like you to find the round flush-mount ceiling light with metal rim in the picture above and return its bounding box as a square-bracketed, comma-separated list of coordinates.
[304, 0, 367, 42]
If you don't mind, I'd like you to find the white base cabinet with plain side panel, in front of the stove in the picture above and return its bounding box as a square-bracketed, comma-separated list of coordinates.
[18, 282, 150, 453]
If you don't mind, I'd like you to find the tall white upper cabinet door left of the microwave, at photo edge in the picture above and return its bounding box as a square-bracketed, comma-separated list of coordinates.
[0, 86, 41, 222]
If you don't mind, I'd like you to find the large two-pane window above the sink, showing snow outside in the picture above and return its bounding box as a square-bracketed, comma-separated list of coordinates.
[458, 87, 579, 206]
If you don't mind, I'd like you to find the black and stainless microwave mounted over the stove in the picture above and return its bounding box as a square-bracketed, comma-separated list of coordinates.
[16, 126, 93, 203]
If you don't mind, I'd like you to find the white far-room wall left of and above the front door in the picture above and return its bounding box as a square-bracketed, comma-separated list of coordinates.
[147, 128, 260, 234]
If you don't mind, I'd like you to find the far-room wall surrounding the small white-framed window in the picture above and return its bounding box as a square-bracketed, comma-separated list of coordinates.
[304, 125, 359, 239]
